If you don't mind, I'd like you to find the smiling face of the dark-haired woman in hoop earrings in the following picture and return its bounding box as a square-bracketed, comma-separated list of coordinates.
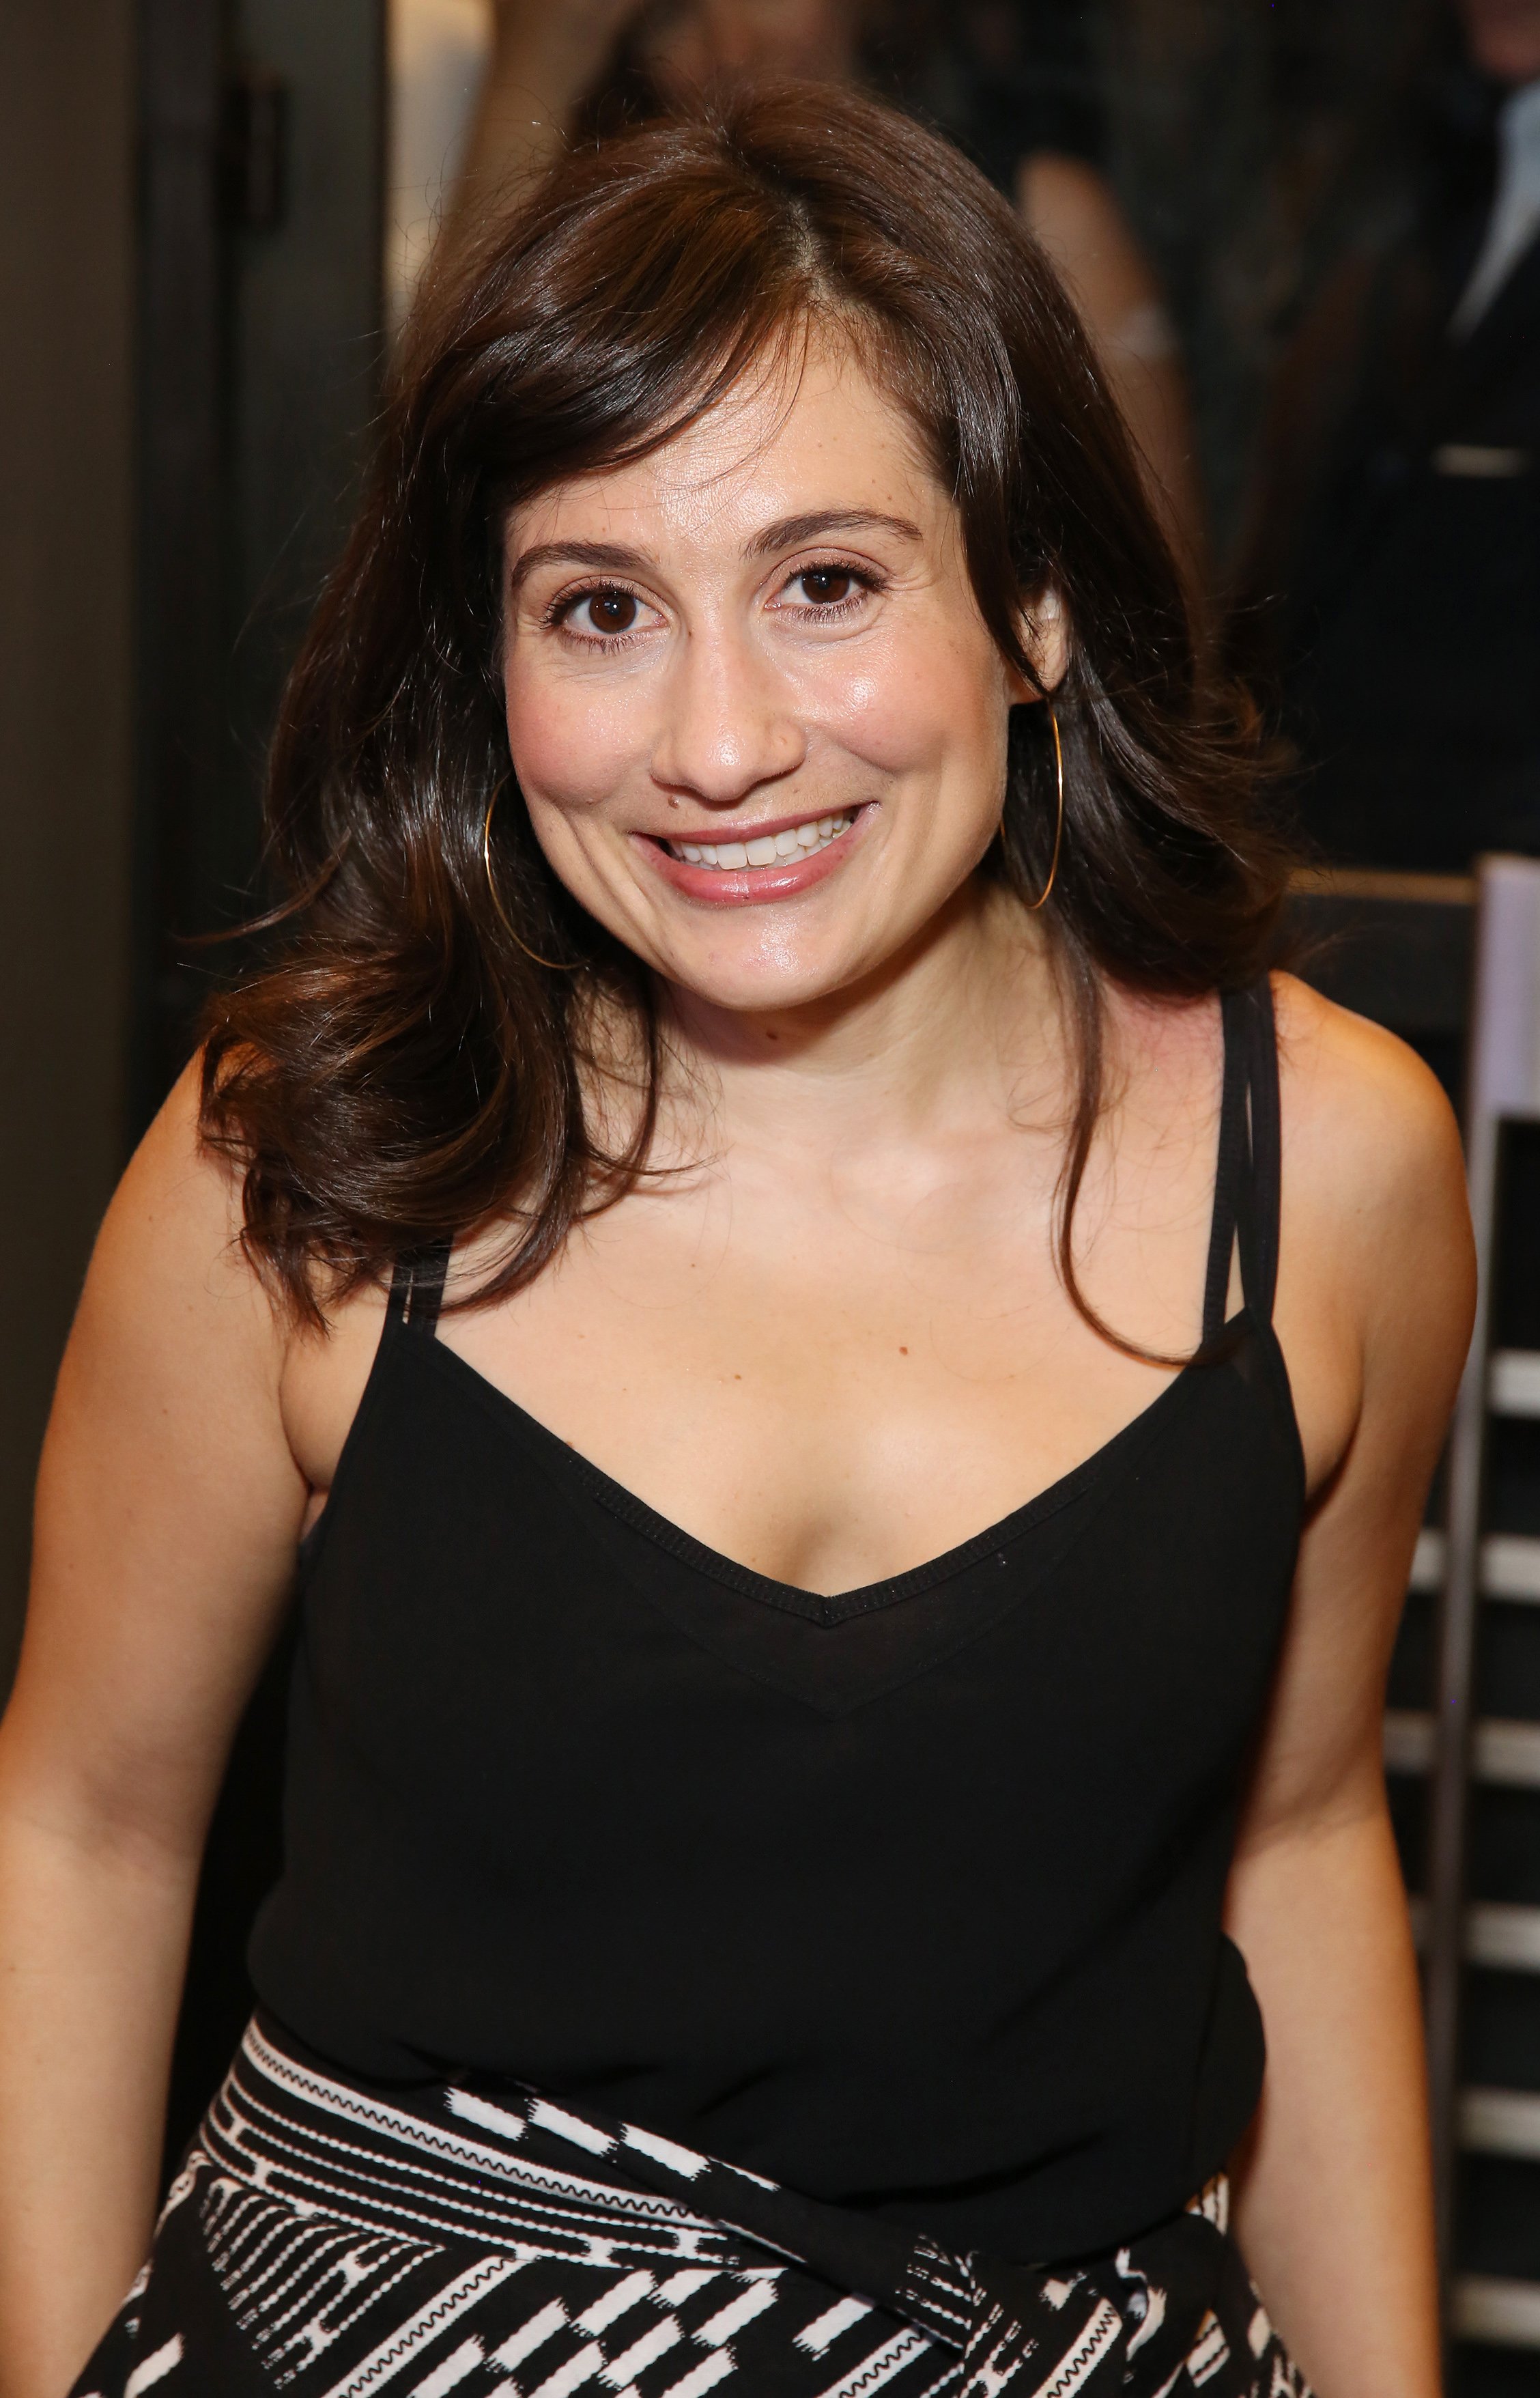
[506, 348, 1063, 1010]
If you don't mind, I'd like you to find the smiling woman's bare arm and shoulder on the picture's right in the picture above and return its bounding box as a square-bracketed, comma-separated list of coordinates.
[1228, 983, 1475, 2398]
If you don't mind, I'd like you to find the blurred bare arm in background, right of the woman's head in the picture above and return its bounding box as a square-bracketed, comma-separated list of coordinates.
[1017, 151, 1209, 587]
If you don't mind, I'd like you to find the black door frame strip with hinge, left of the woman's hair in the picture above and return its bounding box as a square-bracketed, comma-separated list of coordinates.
[132, 0, 384, 1123]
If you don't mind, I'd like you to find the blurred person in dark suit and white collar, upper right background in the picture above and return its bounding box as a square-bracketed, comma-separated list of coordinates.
[1236, 0, 1540, 873]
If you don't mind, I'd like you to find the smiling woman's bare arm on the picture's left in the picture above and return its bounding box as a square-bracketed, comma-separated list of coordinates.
[0, 1069, 307, 2398]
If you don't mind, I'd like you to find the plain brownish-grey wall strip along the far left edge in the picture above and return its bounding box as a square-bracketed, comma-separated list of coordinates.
[0, 0, 134, 1686]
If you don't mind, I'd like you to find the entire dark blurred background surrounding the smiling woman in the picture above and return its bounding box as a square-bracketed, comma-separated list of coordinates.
[0, 0, 1540, 2398]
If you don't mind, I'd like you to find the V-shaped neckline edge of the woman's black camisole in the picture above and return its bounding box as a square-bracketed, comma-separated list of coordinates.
[412, 1307, 1255, 1626]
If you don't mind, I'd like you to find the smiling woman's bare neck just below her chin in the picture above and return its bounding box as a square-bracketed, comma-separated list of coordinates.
[664, 877, 1065, 1163]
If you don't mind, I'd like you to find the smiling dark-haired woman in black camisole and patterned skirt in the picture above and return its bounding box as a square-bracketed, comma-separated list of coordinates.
[0, 86, 1470, 2398]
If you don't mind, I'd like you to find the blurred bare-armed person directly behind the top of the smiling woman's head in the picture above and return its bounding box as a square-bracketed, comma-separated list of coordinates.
[451, 0, 1207, 570]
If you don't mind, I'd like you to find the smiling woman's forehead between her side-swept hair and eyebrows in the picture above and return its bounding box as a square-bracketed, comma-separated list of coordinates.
[509, 341, 955, 556]
